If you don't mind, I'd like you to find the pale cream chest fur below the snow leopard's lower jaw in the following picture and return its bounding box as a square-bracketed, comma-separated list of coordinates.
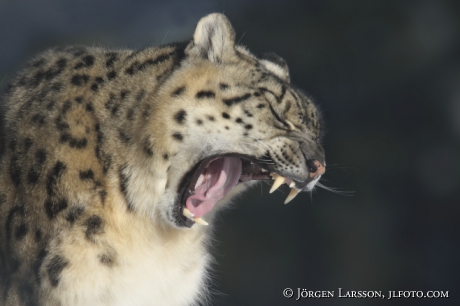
[50, 210, 210, 306]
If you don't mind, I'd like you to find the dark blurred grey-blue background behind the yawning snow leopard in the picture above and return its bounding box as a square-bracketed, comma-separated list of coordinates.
[0, 0, 460, 305]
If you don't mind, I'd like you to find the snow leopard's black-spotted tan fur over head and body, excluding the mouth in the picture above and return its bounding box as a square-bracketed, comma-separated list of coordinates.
[0, 14, 324, 306]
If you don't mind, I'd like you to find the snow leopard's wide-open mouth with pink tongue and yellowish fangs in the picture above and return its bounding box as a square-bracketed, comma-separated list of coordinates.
[175, 154, 322, 227]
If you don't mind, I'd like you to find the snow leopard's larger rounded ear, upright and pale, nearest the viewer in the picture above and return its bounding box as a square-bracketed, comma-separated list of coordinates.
[186, 13, 235, 64]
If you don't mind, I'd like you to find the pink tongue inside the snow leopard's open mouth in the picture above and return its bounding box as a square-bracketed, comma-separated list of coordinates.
[185, 157, 242, 218]
